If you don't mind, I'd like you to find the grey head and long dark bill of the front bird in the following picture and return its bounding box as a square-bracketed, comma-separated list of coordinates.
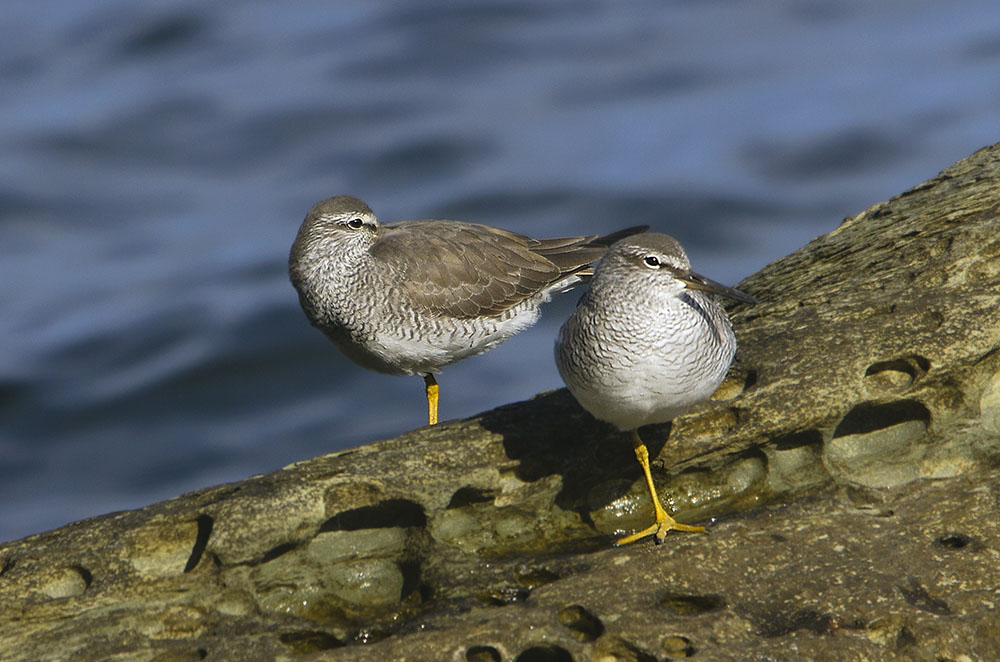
[594, 232, 756, 303]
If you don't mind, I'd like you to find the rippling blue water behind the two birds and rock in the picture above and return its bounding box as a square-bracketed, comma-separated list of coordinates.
[0, 0, 1000, 540]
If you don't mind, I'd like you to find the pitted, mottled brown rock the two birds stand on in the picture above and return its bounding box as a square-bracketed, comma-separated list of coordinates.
[0, 146, 1000, 662]
